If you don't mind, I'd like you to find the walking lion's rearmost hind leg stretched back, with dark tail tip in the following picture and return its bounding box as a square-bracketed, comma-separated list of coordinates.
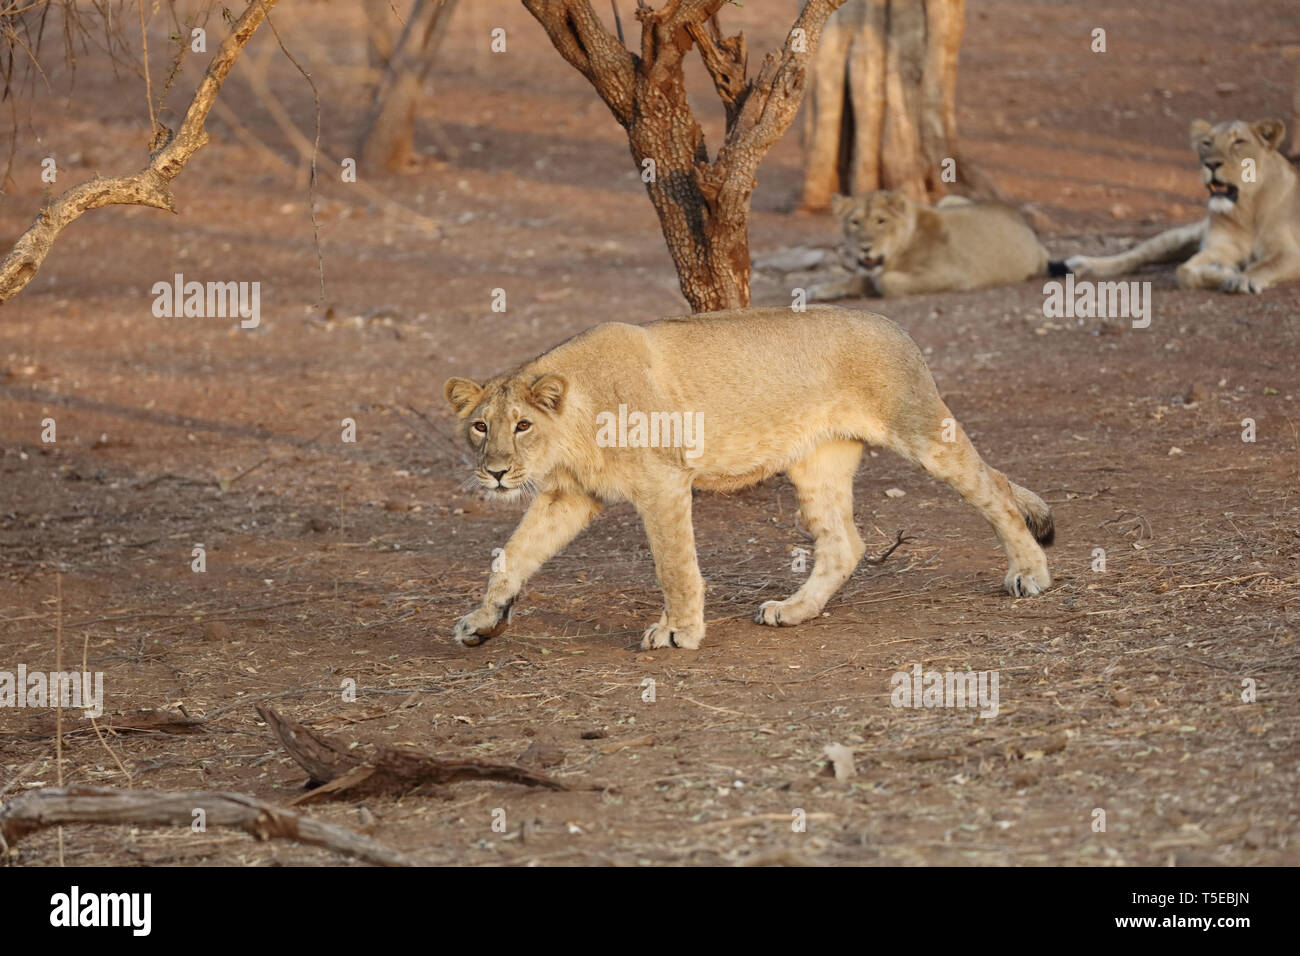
[897, 418, 1054, 597]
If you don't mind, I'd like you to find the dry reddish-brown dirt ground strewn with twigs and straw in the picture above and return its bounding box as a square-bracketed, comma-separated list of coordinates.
[0, 0, 1300, 866]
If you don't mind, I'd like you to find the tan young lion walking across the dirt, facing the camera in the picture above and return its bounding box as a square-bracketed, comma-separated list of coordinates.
[445, 307, 1053, 649]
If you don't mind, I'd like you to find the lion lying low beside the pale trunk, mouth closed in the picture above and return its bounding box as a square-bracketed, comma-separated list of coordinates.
[810, 190, 1048, 300]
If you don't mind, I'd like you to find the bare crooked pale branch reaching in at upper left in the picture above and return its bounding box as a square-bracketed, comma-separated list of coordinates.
[0, 0, 277, 303]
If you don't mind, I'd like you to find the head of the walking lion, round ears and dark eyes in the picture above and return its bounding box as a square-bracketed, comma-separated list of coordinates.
[442, 373, 568, 501]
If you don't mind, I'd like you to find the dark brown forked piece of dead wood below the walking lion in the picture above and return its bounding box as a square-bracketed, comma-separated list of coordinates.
[257, 704, 585, 805]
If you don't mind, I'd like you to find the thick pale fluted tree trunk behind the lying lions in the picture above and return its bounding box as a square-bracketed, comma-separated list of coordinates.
[802, 0, 971, 209]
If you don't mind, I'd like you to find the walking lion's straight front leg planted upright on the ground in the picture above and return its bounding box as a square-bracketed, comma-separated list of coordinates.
[634, 483, 705, 650]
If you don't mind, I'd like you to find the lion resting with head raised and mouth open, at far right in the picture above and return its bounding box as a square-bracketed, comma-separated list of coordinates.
[1065, 120, 1300, 293]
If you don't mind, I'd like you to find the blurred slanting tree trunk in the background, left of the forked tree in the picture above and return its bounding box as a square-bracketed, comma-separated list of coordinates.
[356, 0, 456, 172]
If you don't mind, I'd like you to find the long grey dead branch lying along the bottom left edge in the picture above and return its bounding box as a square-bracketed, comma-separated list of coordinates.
[0, 787, 417, 866]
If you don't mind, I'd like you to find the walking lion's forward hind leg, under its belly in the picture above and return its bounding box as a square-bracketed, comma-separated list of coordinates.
[754, 441, 867, 626]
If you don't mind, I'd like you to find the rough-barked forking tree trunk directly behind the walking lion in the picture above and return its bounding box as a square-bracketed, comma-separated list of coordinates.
[524, 0, 844, 312]
